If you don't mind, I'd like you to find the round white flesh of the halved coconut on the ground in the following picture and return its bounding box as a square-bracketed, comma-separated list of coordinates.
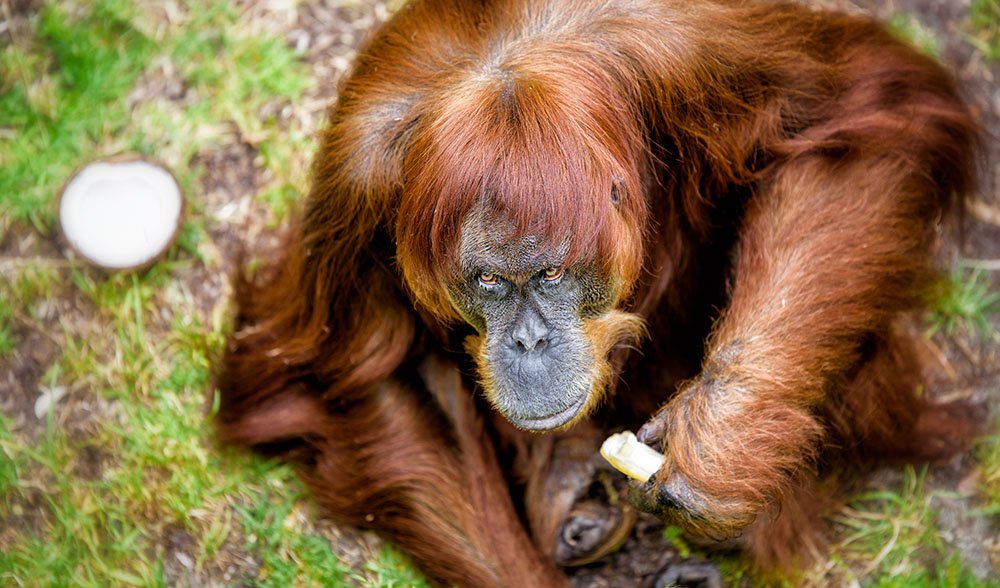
[59, 160, 182, 269]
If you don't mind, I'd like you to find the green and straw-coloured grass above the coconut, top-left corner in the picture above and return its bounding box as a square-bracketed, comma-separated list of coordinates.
[0, 0, 313, 233]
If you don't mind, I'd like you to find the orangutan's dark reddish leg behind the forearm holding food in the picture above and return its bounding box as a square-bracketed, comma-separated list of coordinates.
[740, 324, 973, 569]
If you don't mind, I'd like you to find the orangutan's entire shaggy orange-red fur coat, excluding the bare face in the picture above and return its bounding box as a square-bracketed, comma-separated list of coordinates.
[218, 0, 976, 586]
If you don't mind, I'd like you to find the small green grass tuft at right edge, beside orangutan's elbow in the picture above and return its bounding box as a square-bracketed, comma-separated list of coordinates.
[928, 268, 1000, 337]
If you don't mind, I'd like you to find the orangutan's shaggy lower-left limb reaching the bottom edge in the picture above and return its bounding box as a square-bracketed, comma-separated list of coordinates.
[221, 358, 566, 586]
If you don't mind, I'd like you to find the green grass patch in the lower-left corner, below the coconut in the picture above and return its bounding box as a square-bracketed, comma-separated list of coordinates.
[0, 288, 360, 586]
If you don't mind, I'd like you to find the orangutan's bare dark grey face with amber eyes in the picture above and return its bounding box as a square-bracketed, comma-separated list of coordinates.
[451, 209, 611, 431]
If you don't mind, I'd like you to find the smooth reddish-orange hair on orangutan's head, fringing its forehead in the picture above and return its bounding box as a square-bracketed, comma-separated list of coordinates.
[396, 64, 646, 322]
